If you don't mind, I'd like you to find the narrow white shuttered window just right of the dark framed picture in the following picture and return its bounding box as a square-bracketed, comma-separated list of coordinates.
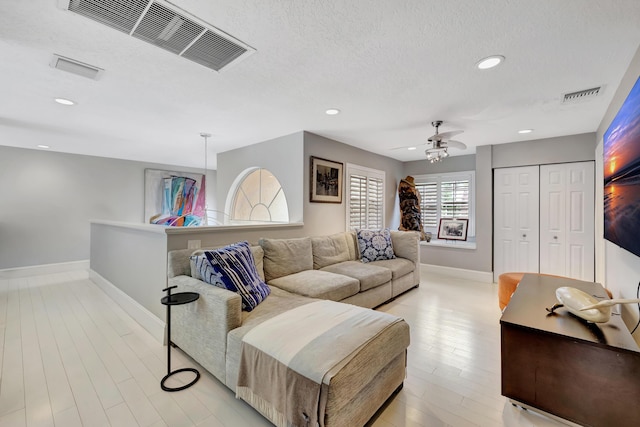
[346, 164, 384, 230]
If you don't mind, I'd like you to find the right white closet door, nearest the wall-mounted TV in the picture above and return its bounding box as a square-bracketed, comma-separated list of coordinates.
[540, 162, 595, 281]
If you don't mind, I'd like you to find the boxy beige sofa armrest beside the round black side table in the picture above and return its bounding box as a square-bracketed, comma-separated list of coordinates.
[169, 275, 242, 383]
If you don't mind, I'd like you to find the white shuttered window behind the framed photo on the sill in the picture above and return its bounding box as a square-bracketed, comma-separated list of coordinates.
[414, 171, 475, 236]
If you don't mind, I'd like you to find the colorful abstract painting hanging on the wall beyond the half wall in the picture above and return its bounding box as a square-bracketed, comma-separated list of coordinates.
[144, 169, 206, 227]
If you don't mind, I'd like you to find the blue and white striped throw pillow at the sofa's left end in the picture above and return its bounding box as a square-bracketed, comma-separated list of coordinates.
[195, 242, 271, 311]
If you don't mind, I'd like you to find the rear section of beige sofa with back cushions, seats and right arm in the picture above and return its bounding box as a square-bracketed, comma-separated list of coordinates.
[259, 231, 420, 308]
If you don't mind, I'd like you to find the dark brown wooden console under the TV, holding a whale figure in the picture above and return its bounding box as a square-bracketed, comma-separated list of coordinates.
[500, 274, 640, 427]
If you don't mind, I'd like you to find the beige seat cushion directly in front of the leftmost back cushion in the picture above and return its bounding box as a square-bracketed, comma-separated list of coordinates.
[269, 270, 360, 301]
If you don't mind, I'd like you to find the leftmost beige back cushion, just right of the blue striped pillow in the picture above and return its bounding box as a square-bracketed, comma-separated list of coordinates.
[259, 237, 313, 282]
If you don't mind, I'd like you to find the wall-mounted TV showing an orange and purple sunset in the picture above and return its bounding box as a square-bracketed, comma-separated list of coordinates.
[604, 78, 640, 256]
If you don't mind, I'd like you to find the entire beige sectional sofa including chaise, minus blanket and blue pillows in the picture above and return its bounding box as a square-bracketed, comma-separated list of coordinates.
[168, 232, 420, 427]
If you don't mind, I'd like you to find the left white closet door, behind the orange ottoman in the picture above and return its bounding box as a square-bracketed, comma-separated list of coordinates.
[493, 166, 540, 282]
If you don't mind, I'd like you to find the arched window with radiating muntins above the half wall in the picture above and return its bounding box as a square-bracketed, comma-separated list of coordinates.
[230, 168, 289, 222]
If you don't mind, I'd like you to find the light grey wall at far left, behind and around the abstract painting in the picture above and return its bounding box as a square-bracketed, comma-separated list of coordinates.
[0, 143, 215, 269]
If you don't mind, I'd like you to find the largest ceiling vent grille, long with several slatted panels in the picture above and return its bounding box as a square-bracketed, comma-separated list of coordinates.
[68, 0, 255, 71]
